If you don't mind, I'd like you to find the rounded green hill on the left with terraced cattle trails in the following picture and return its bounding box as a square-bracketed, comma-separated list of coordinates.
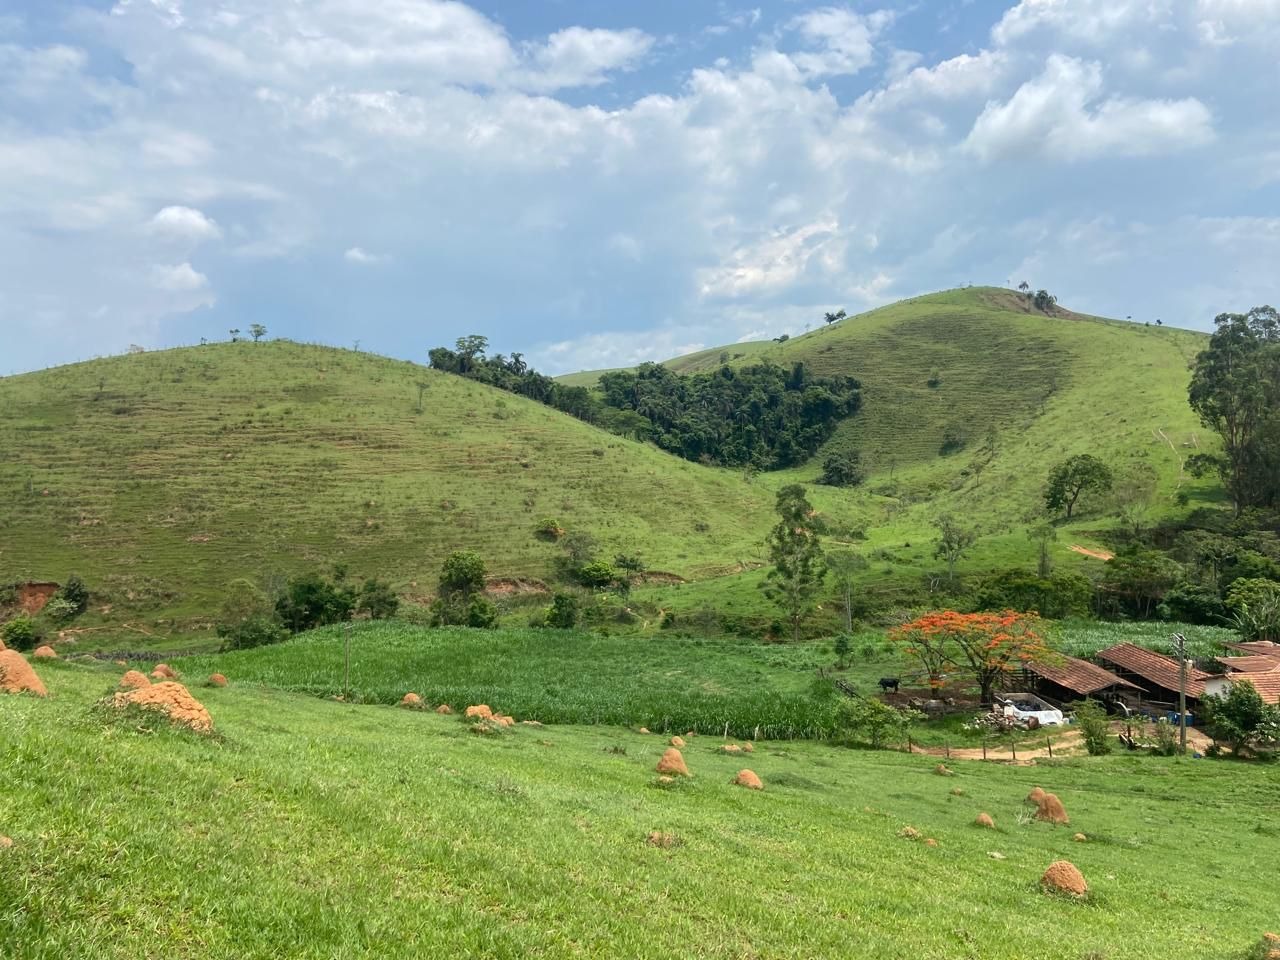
[0, 342, 771, 634]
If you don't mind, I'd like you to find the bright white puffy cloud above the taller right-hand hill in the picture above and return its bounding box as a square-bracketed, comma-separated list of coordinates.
[965, 55, 1213, 163]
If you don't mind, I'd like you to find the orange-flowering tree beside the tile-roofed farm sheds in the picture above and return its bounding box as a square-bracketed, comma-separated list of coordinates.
[890, 611, 1052, 703]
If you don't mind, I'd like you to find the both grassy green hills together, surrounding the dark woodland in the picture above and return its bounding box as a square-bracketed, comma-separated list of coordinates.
[0, 288, 1220, 648]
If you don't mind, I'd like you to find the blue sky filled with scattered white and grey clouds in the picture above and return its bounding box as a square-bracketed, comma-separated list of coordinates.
[0, 0, 1280, 374]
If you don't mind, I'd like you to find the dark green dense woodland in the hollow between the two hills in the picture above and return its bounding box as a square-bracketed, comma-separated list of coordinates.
[430, 335, 861, 470]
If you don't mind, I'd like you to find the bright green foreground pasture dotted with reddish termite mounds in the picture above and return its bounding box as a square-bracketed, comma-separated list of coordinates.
[0, 666, 1280, 960]
